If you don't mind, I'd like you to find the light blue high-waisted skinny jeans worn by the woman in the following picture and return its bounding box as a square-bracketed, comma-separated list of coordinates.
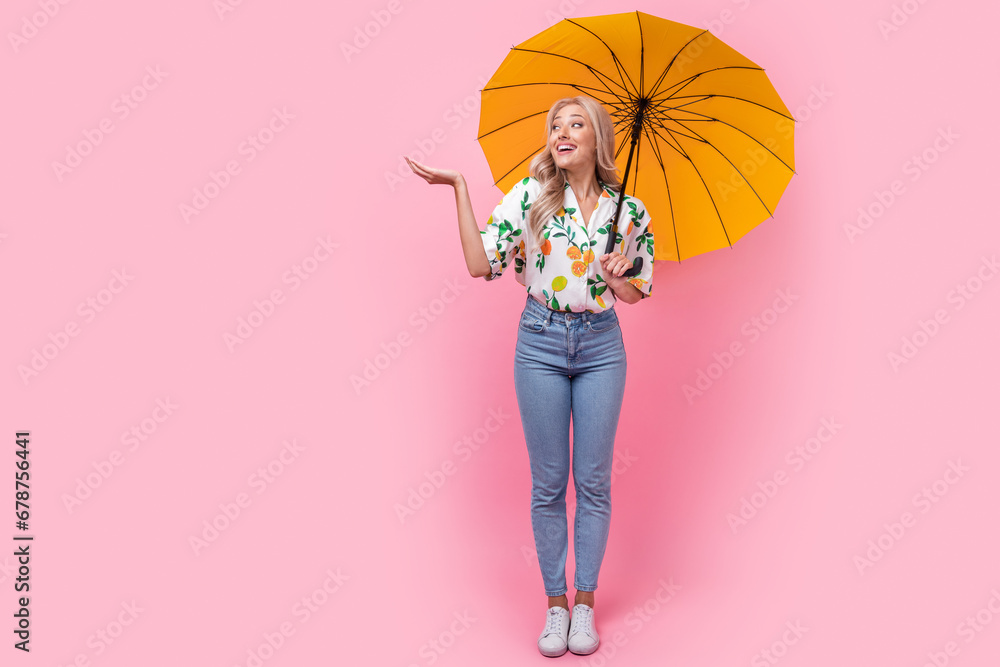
[514, 294, 625, 596]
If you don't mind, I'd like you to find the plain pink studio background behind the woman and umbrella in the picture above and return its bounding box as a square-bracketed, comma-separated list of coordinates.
[0, 0, 1000, 667]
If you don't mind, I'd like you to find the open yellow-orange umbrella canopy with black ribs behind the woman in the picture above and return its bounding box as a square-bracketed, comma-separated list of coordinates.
[479, 12, 795, 262]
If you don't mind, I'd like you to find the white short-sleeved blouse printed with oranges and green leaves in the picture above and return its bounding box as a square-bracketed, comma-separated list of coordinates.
[480, 177, 653, 313]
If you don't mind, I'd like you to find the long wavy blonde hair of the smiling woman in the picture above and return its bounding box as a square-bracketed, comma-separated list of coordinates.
[528, 95, 621, 254]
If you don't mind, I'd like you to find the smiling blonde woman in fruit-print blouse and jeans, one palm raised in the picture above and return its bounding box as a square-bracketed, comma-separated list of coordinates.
[406, 96, 653, 657]
